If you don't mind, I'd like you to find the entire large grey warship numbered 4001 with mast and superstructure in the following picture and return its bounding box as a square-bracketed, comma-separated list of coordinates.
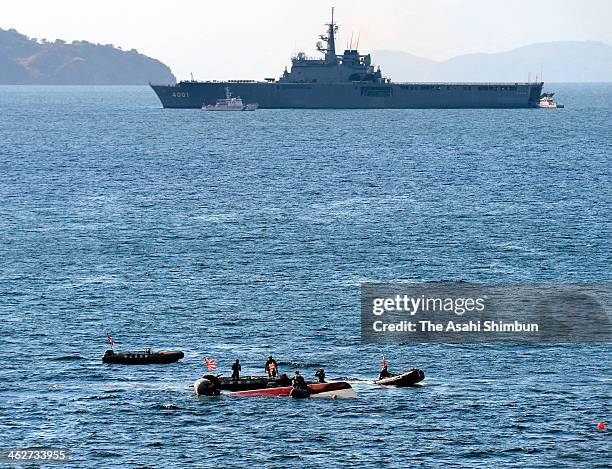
[151, 8, 544, 109]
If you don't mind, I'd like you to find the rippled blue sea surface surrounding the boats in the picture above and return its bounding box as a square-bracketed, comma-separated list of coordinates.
[0, 84, 612, 468]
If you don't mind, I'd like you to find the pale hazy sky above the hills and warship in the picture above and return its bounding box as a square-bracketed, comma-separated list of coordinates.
[0, 0, 612, 79]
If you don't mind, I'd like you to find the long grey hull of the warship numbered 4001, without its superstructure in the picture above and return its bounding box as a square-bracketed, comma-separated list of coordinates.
[151, 81, 543, 109]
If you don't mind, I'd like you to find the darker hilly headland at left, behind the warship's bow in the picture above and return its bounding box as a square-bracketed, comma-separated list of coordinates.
[0, 29, 176, 85]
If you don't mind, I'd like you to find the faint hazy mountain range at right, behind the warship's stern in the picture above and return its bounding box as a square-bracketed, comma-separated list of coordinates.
[372, 41, 612, 82]
